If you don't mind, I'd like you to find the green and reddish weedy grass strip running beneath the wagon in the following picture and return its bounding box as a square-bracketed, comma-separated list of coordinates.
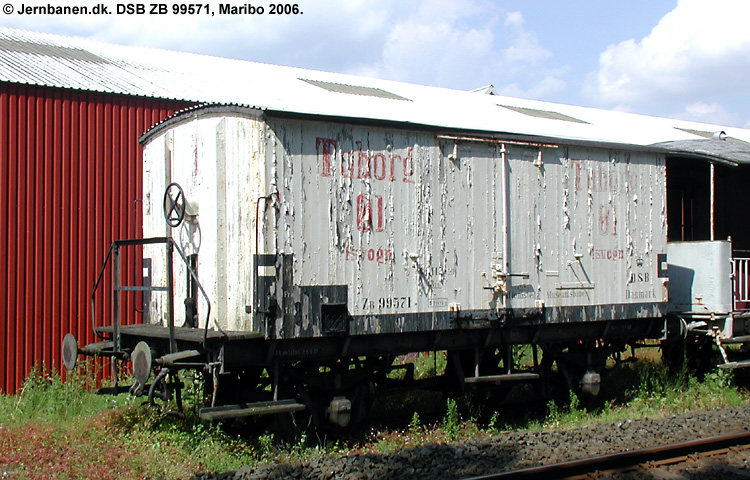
[0, 354, 750, 479]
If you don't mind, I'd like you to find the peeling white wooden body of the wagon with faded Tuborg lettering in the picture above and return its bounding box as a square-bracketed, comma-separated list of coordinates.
[143, 106, 667, 339]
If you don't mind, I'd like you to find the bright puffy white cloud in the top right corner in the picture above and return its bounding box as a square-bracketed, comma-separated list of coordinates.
[584, 0, 750, 125]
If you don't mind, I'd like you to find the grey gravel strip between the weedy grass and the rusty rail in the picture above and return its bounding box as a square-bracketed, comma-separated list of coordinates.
[193, 406, 750, 480]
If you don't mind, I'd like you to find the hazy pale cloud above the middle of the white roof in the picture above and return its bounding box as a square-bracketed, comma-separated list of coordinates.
[350, 6, 567, 98]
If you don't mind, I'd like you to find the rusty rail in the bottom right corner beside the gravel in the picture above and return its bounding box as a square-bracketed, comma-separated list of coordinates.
[471, 431, 750, 480]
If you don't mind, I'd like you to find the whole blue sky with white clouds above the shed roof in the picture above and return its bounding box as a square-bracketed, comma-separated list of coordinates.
[5, 0, 750, 128]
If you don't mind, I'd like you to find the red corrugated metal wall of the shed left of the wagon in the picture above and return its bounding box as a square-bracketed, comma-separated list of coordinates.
[0, 83, 188, 393]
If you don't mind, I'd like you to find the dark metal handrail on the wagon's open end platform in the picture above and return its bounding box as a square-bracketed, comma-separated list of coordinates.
[91, 237, 211, 349]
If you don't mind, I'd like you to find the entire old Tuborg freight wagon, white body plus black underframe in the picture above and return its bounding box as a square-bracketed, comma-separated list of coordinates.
[66, 105, 667, 425]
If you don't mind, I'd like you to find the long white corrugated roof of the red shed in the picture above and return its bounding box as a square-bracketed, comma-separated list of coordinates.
[0, 28, 750, 156]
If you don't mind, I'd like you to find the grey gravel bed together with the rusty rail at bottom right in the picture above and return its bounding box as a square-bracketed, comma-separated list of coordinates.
[188, 405, 750, 480]
